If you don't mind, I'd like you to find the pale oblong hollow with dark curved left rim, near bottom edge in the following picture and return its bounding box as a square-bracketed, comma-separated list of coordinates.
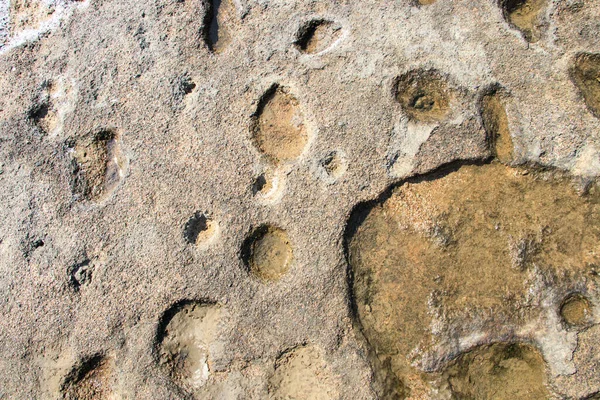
[158, 301, 222, 393]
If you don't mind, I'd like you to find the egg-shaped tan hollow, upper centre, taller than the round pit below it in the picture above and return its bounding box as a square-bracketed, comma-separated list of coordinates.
[251, 85, 308, 164]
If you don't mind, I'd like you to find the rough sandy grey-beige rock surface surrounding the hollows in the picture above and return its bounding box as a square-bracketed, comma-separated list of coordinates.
[0, 0, 600, 399]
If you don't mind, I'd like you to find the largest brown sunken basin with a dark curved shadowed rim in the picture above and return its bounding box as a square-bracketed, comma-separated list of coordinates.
[347, 162, 600, 396]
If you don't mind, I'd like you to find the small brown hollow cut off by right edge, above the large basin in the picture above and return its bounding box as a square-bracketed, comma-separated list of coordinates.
[570, 53, 600, 118]
